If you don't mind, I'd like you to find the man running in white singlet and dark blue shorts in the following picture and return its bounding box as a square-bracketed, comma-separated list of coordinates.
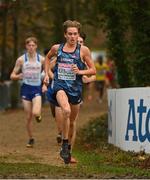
[10, 37, 44, 147]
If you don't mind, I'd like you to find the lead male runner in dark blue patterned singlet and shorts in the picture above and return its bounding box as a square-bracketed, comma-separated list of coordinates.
[44, 20, 96, 163]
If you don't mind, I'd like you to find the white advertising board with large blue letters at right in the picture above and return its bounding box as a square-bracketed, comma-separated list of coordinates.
[108, 87, 150, 153]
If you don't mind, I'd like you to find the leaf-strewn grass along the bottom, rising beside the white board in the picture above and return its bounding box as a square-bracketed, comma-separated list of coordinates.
[0, 115, 150, 179]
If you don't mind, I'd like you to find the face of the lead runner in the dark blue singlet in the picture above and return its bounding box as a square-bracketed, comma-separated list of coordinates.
[65, 27, 79, 45]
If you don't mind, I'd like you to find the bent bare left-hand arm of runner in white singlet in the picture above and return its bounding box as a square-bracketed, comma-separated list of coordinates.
[10, 58, 23, 80]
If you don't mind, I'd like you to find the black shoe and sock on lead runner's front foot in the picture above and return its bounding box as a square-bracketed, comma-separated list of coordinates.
[60, 143, 71, 164]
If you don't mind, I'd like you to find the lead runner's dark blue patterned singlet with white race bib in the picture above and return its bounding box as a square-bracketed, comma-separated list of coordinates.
[53, 44, 85, 97]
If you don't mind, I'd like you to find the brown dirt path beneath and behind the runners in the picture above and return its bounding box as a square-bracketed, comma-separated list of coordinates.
[0, 90, 107, 165]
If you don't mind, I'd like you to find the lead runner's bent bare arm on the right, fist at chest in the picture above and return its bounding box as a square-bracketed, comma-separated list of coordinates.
[73, 46, 96, 75]
